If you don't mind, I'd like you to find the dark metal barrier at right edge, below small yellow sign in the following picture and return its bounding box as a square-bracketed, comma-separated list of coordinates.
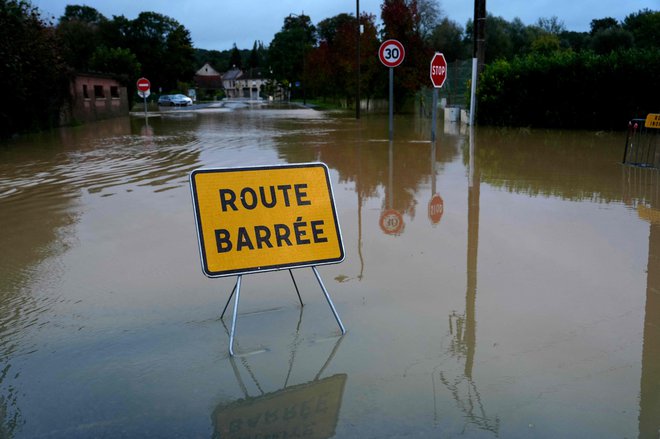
[623, 119, 660, 168]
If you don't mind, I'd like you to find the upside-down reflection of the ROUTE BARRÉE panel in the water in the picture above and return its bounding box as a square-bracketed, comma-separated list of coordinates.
[213, 374, 347, 438]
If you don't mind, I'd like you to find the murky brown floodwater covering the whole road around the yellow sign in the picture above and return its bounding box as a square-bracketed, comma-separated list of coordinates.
[0, 107, 660, 438]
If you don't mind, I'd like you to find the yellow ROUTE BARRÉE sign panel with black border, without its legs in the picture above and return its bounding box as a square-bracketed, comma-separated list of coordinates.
[190, 163, 344, 277]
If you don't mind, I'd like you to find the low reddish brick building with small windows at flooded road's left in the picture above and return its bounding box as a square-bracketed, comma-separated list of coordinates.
[60, 73, 128, 125]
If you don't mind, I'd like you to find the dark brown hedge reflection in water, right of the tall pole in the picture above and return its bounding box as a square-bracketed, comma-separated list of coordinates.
[463, 128, 625, 202]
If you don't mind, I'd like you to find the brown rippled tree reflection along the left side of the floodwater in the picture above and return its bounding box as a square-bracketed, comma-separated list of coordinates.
[0, 118, 199, 437]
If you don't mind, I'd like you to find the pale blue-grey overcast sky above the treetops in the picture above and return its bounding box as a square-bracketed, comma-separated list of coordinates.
[32, 0, 660, 50]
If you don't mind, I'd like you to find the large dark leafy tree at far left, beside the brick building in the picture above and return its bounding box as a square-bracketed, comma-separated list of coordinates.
[0, 0, 68, 137]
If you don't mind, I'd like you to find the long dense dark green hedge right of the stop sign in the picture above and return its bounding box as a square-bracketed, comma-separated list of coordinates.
[477, 49, 660, 129]
